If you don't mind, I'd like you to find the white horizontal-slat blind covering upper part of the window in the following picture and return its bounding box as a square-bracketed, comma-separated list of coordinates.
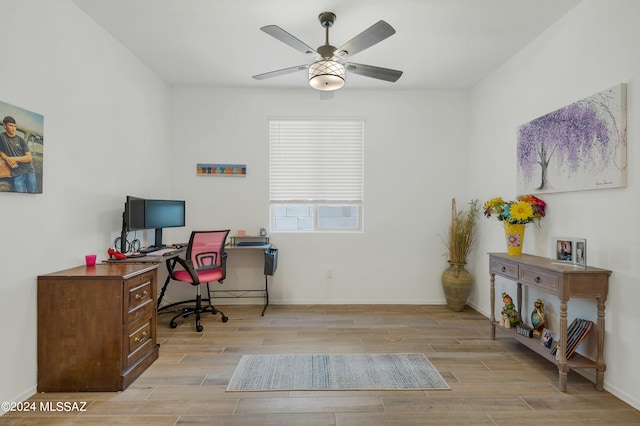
[269, 120, 364, 203]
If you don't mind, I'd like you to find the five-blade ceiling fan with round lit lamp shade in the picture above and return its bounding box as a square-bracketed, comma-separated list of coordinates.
[253, 12, 402, 91]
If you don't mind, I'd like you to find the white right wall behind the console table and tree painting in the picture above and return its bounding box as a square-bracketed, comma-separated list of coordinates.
[469, 0, 640, 407]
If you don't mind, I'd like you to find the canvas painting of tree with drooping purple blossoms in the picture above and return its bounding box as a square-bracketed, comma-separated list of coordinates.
[518, 84, 627, 194]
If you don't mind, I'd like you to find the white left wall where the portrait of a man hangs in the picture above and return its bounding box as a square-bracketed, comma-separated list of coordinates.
[0, 0, 171, 401]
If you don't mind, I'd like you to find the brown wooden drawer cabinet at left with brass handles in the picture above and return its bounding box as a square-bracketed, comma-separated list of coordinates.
[38, 264, 160, 392]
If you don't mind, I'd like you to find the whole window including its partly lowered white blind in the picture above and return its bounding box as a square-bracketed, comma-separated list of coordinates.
[269, 120, 364, 231]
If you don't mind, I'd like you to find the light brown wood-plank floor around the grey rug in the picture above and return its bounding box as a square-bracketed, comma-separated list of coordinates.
[0, 305, 640, 426]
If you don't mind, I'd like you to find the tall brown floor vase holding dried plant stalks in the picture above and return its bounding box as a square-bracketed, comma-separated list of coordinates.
[442, 198, 480, 311]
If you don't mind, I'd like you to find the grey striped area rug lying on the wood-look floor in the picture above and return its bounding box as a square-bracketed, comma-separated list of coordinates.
[227, 353, 449, 392]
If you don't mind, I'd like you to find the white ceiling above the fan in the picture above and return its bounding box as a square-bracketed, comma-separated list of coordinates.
[72, 0, 581, 90]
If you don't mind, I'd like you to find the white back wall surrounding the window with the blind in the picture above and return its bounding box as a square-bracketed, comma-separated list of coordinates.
[165, 88, 468, 303]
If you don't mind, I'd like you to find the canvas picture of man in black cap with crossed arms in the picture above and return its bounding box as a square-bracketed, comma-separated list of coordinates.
[0, 101, 44, 194]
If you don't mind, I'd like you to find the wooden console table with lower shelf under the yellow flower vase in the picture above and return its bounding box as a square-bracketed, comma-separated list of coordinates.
[489, 253, 611, 392]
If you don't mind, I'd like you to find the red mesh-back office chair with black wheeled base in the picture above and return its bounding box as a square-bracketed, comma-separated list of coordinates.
[167, 229, 229, 331]
